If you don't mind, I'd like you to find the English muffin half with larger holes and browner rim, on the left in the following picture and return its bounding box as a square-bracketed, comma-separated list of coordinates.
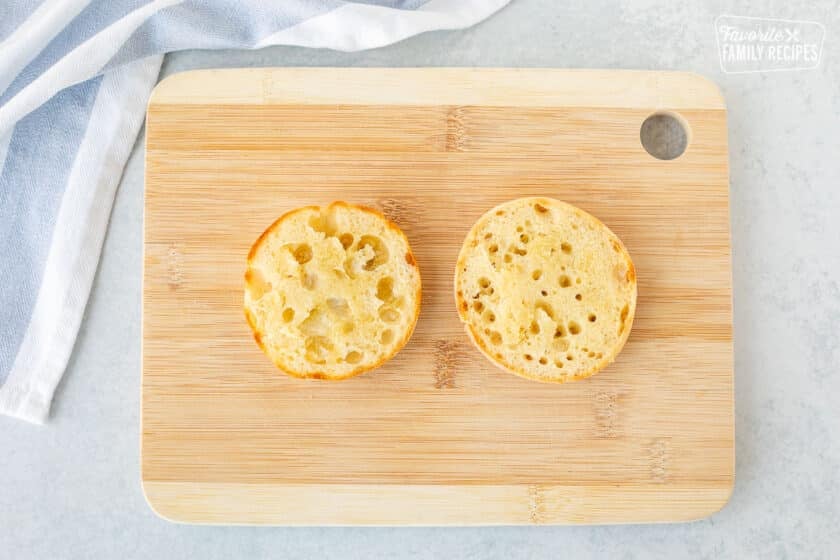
[245, 202, 420, 379]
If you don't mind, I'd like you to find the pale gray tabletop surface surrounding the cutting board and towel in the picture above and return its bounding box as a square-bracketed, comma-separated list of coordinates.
[0, 0, 840, 559]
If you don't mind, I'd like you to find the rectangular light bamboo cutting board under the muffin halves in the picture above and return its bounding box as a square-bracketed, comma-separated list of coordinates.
[142, 68, 734, 525]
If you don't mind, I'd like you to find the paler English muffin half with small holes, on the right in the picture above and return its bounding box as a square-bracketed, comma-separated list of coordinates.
[455, 197, 636, 383]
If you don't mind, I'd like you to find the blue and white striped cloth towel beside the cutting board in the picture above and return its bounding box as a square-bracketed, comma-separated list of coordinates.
[0, 0, 509, 422]
